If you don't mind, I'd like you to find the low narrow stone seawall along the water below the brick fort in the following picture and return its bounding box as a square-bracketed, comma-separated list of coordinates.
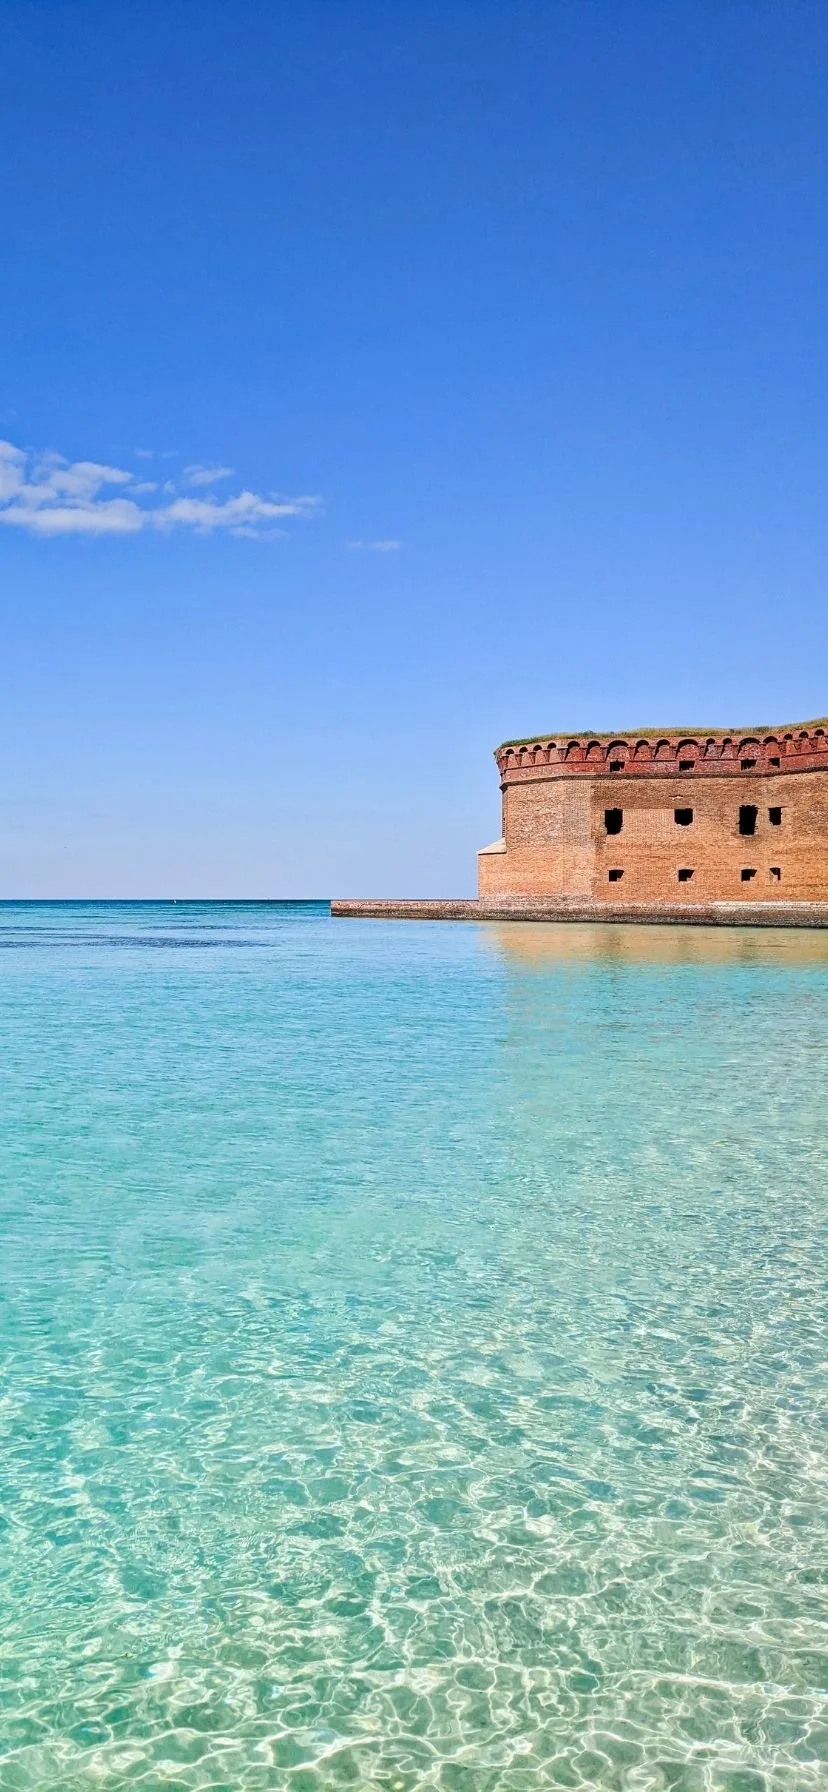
[330, 898, 828, 926]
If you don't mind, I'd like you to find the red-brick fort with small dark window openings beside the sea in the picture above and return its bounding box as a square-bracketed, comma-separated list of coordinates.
[479, 720, 828, 909]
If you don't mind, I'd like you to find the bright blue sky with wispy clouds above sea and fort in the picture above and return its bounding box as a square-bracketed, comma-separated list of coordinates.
[0, 0, 828, 896]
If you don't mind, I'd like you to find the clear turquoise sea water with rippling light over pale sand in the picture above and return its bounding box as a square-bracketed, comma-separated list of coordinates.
[0, 903, 828, 1792]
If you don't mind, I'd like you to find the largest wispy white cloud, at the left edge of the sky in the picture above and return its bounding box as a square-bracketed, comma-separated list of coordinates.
[0, 441, 319, 539]
